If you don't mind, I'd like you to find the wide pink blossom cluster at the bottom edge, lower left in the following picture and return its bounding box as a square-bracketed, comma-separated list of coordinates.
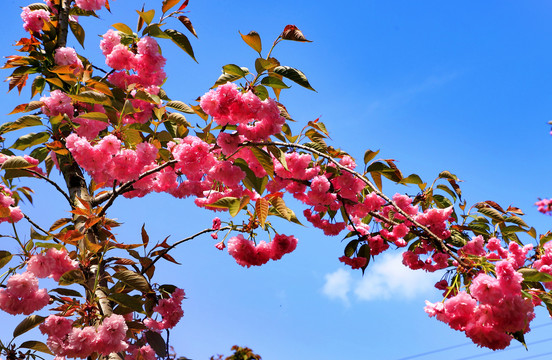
[39, 314, 128, 359]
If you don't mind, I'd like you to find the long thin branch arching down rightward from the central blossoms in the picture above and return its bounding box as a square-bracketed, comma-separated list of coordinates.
[246, 141, 464, 265]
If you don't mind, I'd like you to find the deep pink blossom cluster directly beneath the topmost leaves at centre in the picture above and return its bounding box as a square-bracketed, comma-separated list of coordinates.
[200, 83, 286, 141]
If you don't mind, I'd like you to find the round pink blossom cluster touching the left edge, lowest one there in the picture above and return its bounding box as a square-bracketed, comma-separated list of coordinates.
[0, 271, 50, 315]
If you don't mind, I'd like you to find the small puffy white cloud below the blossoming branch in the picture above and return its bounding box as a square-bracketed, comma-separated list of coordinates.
[322, 253, 440, 304]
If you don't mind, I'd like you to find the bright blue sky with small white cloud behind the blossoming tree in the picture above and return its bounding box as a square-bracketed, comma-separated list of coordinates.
[0, 0, 552, 360]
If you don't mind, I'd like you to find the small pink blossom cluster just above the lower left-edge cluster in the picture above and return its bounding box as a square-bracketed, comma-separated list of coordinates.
[27, 248, 79, 281]
